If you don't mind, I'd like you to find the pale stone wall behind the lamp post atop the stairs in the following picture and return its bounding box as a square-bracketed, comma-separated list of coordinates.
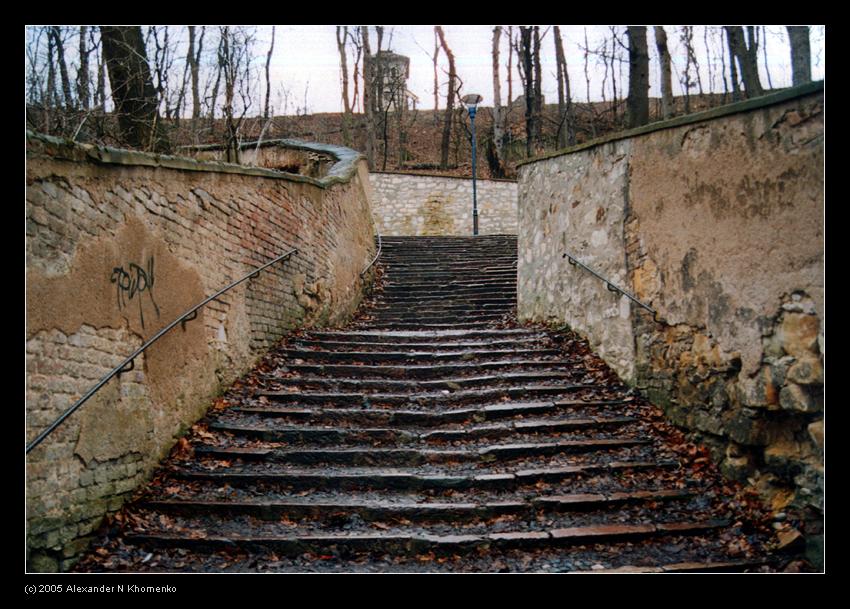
[370, 172, 517, 236]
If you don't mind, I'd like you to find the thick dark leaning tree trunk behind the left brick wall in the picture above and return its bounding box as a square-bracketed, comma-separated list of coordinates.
[100, 26, 169, 152]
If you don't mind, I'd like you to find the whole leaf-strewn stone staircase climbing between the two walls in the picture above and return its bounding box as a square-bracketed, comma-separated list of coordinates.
[77, 236, 770, 572]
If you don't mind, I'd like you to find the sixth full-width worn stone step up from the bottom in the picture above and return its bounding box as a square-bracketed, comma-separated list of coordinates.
[233, 400, 629, 426]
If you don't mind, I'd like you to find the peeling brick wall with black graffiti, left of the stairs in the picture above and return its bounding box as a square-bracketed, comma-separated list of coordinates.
[26, 134, 375, 571]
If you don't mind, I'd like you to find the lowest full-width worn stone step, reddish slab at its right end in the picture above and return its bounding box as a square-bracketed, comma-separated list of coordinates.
[127, 520, 729, 556]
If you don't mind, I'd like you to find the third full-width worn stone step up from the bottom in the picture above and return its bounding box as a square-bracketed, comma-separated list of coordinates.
[176, 461, 679, 490]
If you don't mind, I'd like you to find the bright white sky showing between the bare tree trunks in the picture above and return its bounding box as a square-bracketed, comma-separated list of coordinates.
[256, 25, 825, 114]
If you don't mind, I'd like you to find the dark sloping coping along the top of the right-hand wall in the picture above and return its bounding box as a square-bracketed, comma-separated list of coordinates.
[517, 80, 824, 168]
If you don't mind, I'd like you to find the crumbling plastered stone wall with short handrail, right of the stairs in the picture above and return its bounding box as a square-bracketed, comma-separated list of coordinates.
[518, 83, 824, 550]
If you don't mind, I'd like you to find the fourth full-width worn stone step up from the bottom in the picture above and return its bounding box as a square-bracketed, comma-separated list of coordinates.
[189, 438, 651, 466]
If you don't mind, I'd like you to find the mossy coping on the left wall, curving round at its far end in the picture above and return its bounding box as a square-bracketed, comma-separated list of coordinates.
[26, 130, 365, 188]
